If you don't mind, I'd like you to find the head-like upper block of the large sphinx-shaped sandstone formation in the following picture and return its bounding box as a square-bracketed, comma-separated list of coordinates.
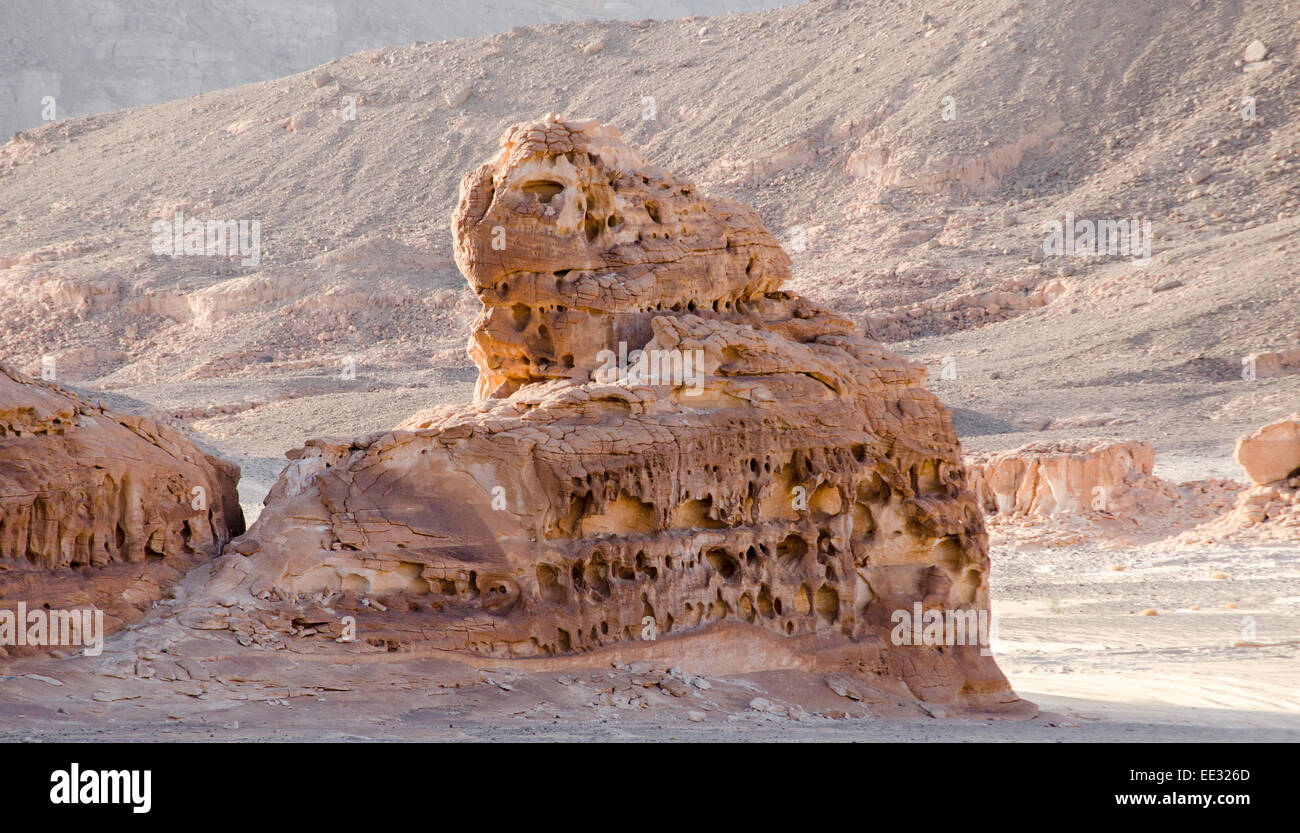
[452, 120, 785, 396]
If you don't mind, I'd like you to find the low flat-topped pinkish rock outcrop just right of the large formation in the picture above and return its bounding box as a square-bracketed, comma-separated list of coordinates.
[966, 439, 1156, 515]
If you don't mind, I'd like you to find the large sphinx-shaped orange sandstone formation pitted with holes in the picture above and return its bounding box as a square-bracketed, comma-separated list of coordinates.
[220, 116, 1032, 712]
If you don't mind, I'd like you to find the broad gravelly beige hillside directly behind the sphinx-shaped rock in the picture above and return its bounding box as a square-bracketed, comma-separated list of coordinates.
[0, 0, 1300, 506]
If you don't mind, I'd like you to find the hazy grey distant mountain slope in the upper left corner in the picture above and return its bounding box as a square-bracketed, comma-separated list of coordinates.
[0, 0, 776, 139]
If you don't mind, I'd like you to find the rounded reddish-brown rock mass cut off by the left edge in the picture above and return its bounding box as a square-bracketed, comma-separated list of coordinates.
[0, 365, 243, 656]
